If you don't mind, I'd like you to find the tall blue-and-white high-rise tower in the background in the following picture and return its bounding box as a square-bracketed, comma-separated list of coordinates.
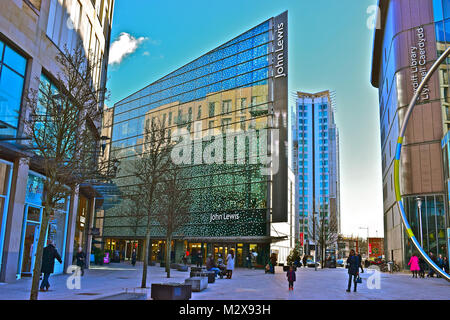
[294, 91, 340, 254]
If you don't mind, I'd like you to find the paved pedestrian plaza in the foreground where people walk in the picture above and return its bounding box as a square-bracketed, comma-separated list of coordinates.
[0, 262, 450, 300]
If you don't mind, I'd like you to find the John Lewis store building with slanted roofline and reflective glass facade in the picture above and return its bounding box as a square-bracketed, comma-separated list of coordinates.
[101, 12, 288, 264]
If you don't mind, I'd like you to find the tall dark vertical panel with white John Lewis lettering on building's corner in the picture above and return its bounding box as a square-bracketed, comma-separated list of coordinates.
[272, 11, 288, 222]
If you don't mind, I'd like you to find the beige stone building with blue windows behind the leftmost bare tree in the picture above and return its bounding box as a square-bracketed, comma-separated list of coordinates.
[0, 0, 114, 282]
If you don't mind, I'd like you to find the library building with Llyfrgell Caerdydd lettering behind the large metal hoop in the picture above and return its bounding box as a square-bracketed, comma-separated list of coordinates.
[371, 0, 450, 268]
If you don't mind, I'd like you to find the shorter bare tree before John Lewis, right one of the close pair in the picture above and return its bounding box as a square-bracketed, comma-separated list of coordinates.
[155, 164, 191, 278]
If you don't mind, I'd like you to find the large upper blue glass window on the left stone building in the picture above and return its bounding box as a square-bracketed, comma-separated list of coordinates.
[0, 41, 27, 136]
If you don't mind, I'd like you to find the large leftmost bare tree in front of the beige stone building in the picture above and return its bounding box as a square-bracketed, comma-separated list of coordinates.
[22, 44, 105, 300]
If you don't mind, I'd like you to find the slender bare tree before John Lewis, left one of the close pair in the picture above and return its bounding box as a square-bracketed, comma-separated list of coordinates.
[129, 118, 172, 288]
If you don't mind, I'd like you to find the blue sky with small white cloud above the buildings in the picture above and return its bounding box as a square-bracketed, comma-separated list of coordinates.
[107, 0, 383, 236]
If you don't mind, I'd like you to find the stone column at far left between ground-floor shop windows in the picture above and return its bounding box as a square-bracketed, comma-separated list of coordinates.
[0, 158, 29, 282]
